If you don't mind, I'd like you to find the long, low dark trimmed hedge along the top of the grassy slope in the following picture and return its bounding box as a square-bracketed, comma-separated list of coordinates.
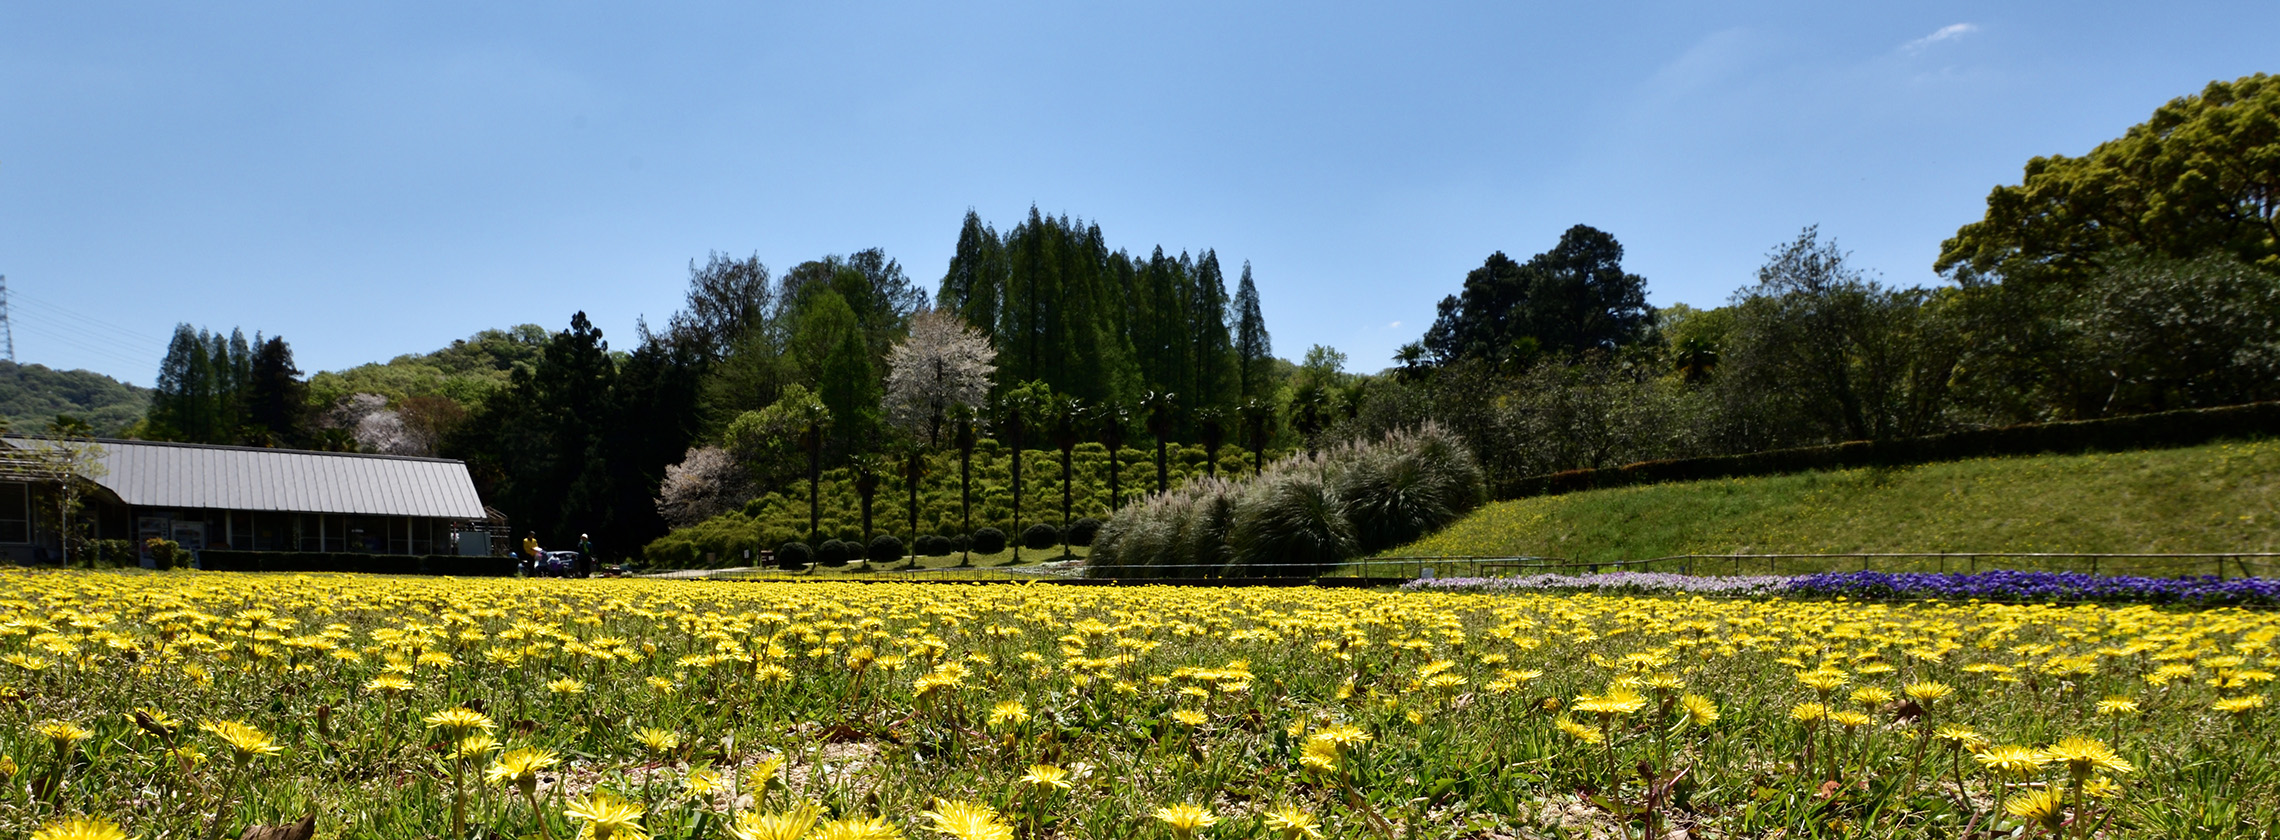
[1496, 402, 2280, 500]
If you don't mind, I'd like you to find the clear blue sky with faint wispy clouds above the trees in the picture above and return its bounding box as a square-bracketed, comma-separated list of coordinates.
[0, 2, 2280, 383]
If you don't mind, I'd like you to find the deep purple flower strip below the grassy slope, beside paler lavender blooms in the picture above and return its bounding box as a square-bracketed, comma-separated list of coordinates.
[1785, 571, 2280, 605]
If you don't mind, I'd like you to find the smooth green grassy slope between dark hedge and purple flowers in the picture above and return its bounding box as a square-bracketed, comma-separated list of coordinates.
[1389, 441, 2280, 570]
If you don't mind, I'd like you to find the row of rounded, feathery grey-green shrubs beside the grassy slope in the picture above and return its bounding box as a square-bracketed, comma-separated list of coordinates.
[1088, 422, 1487, 578]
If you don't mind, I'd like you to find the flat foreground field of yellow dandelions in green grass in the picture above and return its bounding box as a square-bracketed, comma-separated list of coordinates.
[0, 571, 2280, 840]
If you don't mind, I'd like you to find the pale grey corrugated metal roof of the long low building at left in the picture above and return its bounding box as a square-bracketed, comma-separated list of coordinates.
[9, 438, 483, 518]
